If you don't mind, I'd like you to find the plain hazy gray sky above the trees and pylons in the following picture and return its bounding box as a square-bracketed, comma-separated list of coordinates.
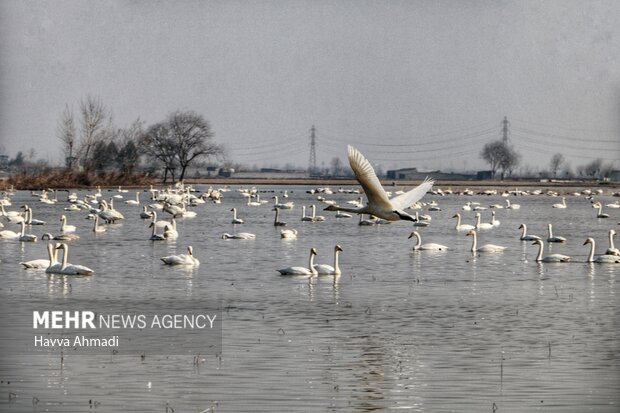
[0, 0, 620, 169]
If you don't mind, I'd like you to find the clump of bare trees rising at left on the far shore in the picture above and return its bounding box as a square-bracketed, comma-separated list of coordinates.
[56, 95, 223, 182]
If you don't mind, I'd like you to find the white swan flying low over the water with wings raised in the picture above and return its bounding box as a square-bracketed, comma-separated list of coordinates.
[325, 145, 433, 222]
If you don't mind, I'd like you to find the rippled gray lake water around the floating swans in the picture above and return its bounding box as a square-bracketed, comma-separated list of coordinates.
[0, 187, 620, 412]
